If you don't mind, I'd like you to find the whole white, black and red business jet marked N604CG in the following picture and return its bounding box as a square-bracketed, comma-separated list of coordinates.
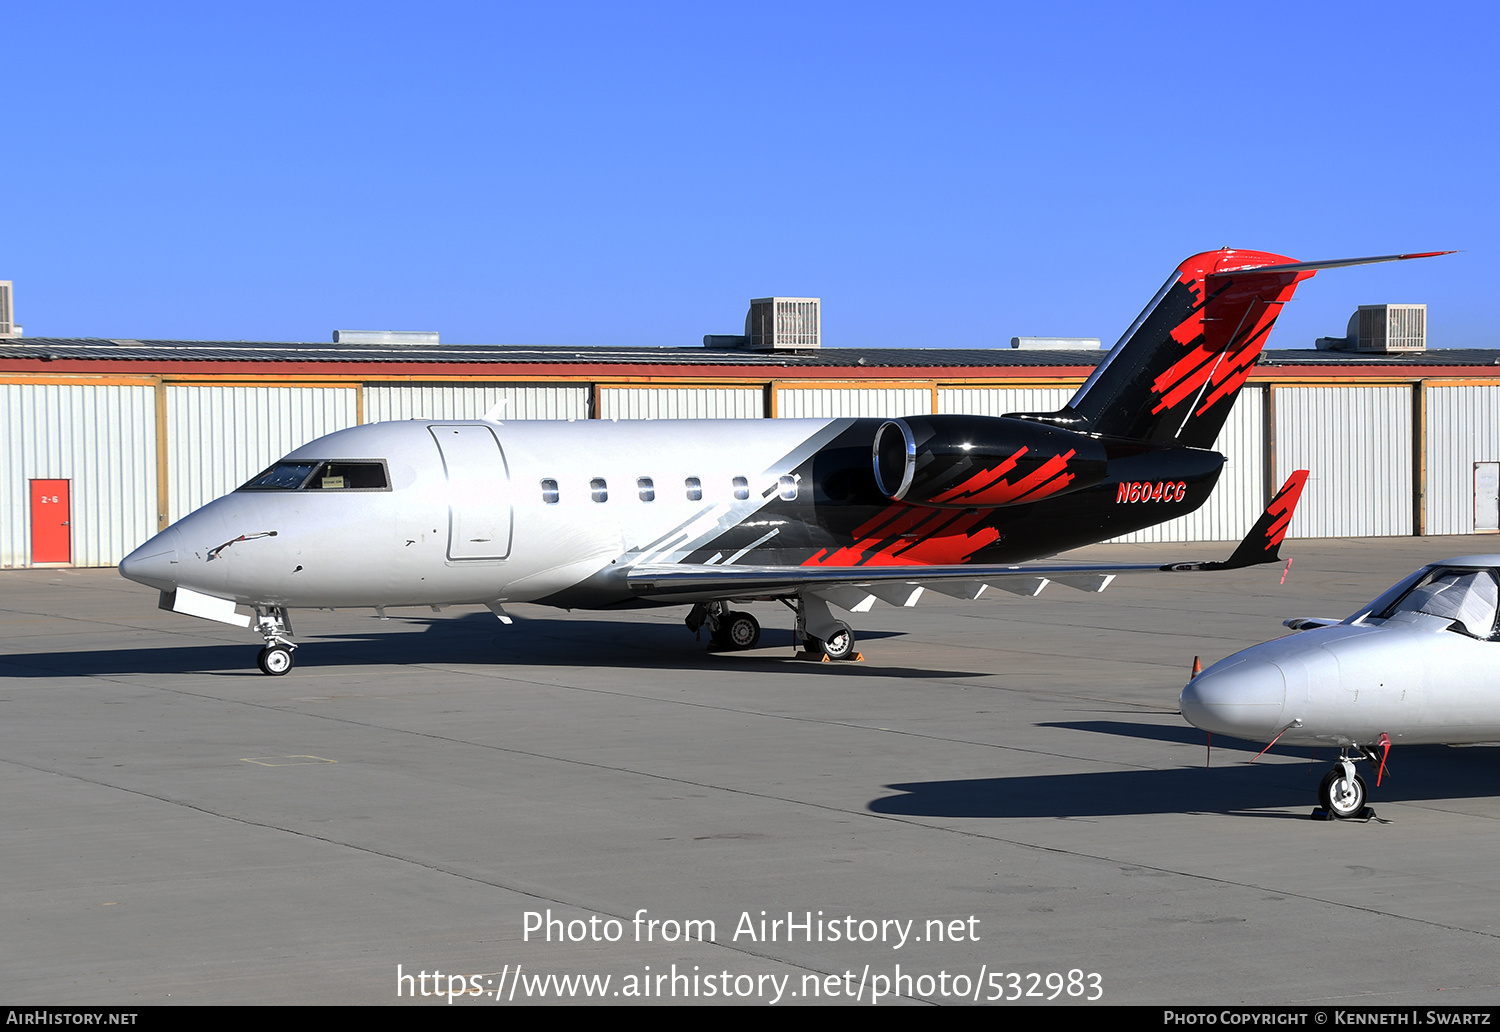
[120, 248, 1446, 674]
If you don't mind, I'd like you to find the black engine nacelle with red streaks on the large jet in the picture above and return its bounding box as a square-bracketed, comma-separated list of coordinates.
[873, 416, 1109, 509]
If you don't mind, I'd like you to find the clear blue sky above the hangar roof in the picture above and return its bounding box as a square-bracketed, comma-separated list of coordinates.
[0, 2, 1500, 348]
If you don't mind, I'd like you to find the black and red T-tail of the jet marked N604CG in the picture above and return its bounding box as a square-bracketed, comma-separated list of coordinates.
[1016, 248, 1452, 449]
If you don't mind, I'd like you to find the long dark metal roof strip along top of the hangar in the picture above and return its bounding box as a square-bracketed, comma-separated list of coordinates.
[0, 338, 1500, 369]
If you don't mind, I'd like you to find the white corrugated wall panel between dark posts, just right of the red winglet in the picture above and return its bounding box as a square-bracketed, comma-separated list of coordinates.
[1275, 387, 1412, 537]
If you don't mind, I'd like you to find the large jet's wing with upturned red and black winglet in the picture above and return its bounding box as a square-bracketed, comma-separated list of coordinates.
[627, 470, 1308, 612]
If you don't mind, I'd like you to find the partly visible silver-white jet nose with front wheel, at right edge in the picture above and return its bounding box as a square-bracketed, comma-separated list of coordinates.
[1181, 555, 1500, 819]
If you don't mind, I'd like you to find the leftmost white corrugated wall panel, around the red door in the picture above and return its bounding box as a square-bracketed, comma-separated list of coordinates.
[0, 384, 156, 567]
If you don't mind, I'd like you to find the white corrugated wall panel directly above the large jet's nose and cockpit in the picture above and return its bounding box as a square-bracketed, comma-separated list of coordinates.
[168, 386, 365, 519]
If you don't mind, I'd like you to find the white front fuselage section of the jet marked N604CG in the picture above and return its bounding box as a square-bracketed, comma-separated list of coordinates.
[120, 420, 849, 608]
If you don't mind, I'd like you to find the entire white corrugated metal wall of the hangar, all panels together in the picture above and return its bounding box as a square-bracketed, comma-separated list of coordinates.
[11, 370, 1500, 567]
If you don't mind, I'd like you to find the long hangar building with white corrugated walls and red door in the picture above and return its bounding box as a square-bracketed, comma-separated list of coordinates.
[0, 334, 1500, 567]
